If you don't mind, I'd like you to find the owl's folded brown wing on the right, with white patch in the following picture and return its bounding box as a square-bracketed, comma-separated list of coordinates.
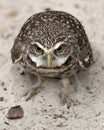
[79, 43, 94, 69]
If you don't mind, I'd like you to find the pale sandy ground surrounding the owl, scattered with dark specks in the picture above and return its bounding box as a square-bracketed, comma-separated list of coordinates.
[0, 0, 104, 130]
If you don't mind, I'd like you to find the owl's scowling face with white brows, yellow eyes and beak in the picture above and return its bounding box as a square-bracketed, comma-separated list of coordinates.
[29, 42, 69, 68]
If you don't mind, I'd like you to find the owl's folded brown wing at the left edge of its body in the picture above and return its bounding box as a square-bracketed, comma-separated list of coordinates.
[11, 39, 24, 63]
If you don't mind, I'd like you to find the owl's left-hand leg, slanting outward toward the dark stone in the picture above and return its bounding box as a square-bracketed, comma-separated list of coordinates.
[23, 76, 43, 101]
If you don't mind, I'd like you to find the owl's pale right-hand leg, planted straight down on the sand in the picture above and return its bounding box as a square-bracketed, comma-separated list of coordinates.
[60, 78, 71, 108]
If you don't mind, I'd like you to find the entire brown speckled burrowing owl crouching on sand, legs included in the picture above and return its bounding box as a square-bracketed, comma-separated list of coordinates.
[11, 11, 93, 104]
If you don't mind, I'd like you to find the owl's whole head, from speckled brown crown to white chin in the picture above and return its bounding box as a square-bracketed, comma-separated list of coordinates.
[19, 11, 80, 68]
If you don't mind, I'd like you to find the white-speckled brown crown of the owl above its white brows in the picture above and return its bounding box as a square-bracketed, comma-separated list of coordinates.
[19, 11, 80, 48]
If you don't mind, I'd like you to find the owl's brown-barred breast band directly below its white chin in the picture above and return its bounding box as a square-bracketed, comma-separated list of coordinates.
[21, 55, 80, 78]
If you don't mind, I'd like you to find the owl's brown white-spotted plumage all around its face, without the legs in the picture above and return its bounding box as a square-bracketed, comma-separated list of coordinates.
[11, 11, 93, 77]
